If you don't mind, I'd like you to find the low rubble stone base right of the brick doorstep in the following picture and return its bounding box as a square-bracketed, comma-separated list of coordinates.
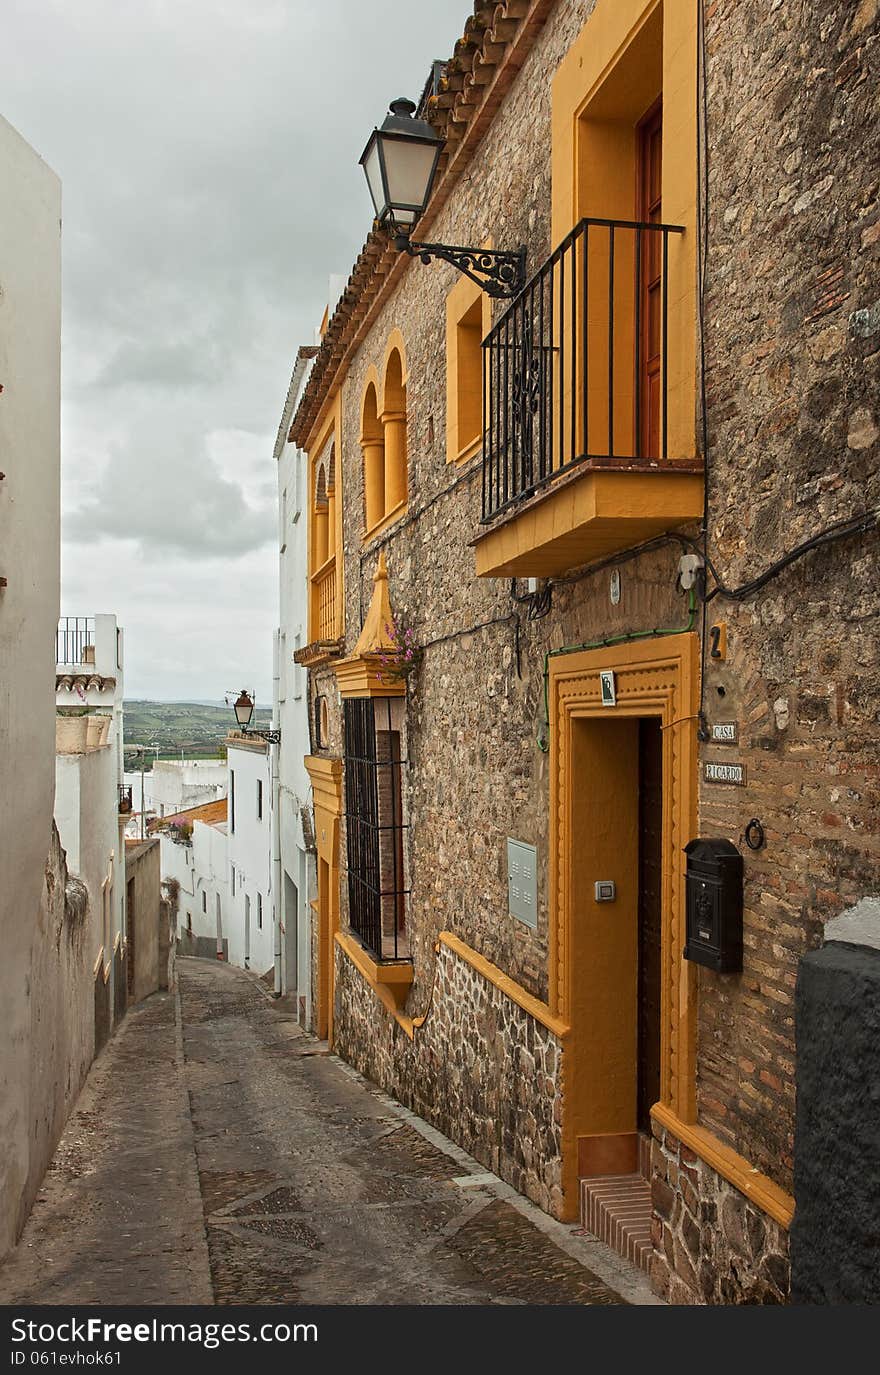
[650, 1123, 789, 1304]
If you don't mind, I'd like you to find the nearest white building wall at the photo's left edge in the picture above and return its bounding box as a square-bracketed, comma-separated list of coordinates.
[0, 118, 65, 1255]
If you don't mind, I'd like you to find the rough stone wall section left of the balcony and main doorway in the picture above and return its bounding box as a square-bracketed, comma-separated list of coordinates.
[317, 0, 686, 998]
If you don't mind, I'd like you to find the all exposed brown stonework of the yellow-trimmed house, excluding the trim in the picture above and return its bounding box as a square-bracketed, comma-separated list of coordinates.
[303, 0, 880, 1301]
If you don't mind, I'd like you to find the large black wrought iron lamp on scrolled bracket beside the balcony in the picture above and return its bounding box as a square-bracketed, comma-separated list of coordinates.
[360, 96, 525, 298]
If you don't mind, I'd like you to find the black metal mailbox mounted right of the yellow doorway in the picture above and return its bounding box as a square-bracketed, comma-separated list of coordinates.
[685, 840, 743, 974]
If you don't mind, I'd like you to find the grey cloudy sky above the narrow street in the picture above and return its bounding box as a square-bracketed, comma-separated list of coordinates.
[0, 0, 469, 700]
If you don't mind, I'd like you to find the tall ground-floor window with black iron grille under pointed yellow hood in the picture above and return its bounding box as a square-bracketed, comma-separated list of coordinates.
[344, 697, 410, 960]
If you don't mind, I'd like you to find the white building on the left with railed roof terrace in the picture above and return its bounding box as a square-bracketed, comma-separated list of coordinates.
[55, 615, 131, 1049]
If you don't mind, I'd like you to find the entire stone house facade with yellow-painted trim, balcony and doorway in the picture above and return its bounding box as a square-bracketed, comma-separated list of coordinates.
[290, 0, 880, 1304]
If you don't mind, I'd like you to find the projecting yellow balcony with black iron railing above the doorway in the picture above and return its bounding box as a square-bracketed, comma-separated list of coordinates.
[474, 219, 703, 578]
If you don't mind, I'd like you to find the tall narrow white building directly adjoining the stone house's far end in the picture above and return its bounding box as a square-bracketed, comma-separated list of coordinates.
[272, 348, 316, 1026]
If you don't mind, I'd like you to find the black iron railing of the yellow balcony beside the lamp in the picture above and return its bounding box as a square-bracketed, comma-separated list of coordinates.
[483, 219, 685, 521]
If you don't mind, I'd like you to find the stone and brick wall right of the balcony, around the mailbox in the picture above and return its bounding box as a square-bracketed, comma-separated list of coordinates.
[699, 0, 880, 1191]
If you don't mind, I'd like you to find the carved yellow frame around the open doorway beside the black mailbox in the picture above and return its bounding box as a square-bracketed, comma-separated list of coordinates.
[549, 633, 700, 1217]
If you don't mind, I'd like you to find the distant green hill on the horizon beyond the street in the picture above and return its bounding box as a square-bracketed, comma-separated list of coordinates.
[122, 699, 272, 769]
